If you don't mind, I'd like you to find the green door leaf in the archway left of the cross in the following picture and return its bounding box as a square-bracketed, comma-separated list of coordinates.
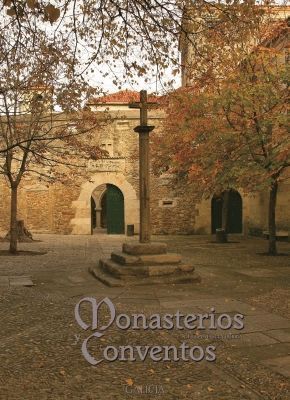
[106, 184, 125, 234]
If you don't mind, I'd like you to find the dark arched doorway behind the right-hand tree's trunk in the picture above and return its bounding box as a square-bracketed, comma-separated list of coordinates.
[211, 189, 243, 233]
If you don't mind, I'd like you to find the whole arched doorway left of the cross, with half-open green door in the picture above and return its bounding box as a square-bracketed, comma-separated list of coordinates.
[91, 184, 125, 234]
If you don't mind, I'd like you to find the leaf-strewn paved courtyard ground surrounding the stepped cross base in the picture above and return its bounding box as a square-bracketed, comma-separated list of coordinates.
[0, 234, 290, 400]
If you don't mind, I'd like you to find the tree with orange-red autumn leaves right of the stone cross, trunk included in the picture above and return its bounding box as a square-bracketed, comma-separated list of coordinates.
[154, 47, 290, 255]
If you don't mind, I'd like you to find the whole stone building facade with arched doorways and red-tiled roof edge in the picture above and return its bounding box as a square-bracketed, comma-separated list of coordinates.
[0, 86, 290, 235]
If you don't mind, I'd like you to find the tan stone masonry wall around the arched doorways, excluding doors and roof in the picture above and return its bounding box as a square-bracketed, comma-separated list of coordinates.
[0, 106, 290, 238]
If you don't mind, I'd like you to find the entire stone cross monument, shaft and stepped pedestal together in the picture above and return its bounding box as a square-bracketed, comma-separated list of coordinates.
[90, 90, 200, 286]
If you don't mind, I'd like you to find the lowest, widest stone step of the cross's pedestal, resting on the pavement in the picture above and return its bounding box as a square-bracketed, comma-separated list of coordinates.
[89, 266, 201, 287]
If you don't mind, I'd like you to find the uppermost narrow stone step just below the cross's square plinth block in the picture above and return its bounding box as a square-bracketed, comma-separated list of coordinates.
[111, 252, 181, 265]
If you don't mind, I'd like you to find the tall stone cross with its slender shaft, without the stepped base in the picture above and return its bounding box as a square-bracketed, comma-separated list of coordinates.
[129, 90, 156, 243]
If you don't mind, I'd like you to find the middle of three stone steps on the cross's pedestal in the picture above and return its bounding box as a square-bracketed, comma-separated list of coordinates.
[99, 259, 194, 278]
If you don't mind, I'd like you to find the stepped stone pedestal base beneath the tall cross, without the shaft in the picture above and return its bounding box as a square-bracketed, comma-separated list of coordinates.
[90, 243, 200, 287]
